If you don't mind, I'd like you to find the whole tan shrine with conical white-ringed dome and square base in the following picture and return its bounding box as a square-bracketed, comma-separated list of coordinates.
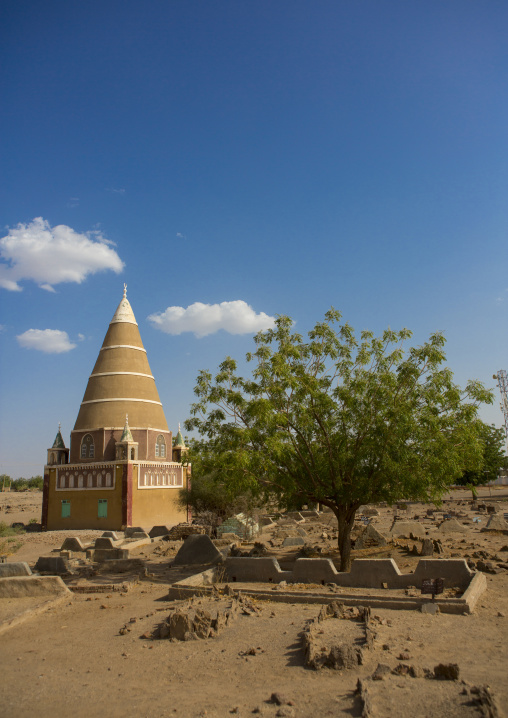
[42, 285, 190, 530]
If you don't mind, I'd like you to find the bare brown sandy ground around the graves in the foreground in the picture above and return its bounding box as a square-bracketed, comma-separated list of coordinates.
[0, 490, 508, 718]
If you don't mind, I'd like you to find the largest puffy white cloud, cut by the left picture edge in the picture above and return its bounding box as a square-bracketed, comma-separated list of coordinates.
[0, 217, 124, 292]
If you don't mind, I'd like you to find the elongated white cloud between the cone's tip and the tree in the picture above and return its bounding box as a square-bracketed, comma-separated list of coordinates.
[148, 299, 275, 337]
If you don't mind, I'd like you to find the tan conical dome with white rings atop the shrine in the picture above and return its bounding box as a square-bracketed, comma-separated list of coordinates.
[74, 287, 168, 431]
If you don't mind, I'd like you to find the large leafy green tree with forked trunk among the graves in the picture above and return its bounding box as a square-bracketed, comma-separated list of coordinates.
[186, 308, 493, 571]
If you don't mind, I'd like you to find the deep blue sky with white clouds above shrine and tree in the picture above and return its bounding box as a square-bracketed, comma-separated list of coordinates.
[0, 0, 508, 478]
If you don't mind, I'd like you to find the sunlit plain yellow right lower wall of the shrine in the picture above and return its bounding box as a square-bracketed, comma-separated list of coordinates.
[132, 466, 187, 529]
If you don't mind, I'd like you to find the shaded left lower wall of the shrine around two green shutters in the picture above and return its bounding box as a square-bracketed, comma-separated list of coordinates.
[48, 467, 122, 531]
